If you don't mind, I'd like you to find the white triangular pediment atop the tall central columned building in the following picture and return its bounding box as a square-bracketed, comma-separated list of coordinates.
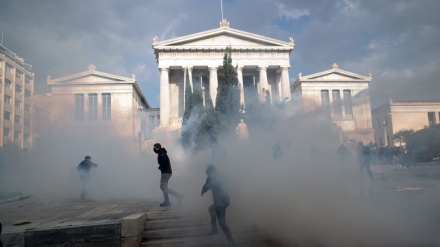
[153, 27, 294, 50]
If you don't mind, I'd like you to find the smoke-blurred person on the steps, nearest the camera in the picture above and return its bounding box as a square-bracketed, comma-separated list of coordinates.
[201, 164, 235, 246]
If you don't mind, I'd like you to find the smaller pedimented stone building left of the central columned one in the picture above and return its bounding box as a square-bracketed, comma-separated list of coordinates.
[45, 65, 154, 150]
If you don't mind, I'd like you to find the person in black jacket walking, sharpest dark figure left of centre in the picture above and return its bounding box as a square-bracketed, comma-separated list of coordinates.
[153, 143, 183, 207]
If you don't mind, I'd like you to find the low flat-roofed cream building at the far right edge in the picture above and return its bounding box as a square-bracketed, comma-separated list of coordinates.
[372, 99, 440, 146]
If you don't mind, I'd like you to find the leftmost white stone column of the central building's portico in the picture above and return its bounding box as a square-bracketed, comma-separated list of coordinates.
[160, 68, 170, 127]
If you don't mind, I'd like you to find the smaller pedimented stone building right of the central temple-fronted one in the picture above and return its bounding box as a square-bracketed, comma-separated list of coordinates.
[291, 64, 374, 143]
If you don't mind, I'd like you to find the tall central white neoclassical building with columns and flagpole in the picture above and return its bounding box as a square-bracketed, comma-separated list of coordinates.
[153, 19, 294, 129]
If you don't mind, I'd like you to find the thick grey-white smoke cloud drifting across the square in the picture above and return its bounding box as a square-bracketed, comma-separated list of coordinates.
[0, 103, 440, 246]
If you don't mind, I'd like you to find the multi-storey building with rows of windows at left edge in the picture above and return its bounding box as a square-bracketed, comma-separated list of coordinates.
[0, 45, 34, 150]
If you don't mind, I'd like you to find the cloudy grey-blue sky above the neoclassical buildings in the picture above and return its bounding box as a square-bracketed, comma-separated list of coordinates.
[0, 0, 440, 108]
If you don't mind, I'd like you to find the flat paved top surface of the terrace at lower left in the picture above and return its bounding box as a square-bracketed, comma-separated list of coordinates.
[0, 196, 155, 233]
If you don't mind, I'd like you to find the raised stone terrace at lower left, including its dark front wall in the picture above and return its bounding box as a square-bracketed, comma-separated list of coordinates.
[0, 195, 160, 247]
